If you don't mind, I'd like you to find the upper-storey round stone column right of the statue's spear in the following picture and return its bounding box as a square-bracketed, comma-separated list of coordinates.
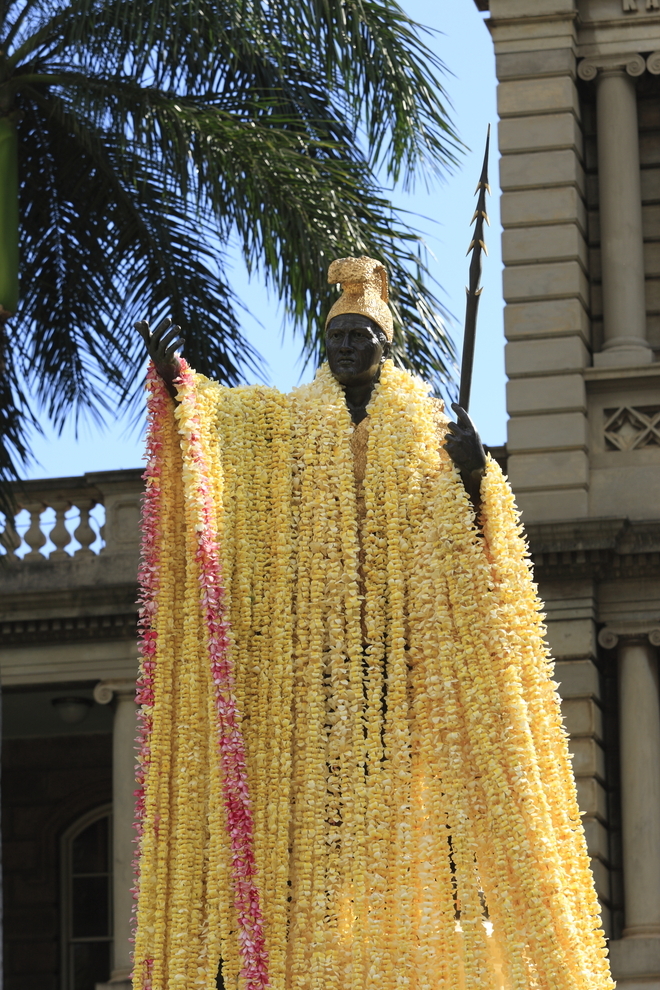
[594, 60, 653, 366]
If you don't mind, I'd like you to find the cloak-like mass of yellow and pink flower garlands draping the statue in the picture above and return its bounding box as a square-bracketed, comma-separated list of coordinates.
[134, 361, 613, 990]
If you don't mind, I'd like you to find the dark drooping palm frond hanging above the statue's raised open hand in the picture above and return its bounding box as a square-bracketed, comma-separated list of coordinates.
[16, 87, 258, 424]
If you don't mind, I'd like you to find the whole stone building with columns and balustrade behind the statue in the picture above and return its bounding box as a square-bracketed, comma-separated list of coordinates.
[0, 0, 660, 990]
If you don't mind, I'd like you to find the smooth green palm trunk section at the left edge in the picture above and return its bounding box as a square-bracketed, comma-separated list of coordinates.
[0, 116, 18, 319]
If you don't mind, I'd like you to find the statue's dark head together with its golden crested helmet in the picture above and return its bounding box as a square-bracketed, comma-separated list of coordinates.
[325, 257, 393, 385]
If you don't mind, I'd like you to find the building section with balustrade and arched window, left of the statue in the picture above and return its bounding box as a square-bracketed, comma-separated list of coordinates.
[0, 471, 142, 990]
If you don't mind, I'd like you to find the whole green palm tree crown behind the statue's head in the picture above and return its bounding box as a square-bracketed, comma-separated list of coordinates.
[0, 0, 459, 496]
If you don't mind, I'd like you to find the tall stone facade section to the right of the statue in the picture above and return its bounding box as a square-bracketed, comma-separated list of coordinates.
[477, 0, 660, 990]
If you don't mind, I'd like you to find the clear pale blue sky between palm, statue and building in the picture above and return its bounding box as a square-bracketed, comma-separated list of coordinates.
[26, 0, 506, 478]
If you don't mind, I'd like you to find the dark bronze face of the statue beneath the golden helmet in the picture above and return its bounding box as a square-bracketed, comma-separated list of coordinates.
[325, 313, 390, 386]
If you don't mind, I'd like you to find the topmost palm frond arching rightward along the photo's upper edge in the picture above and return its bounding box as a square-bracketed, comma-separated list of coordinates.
[6, 0, 460, 182]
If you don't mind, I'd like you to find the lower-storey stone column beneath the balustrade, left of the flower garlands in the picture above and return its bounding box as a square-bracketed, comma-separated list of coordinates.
[94, 679, 137, 990]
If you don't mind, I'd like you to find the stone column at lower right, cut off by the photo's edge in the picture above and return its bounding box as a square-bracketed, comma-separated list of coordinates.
[619, 638, 660, 938]
